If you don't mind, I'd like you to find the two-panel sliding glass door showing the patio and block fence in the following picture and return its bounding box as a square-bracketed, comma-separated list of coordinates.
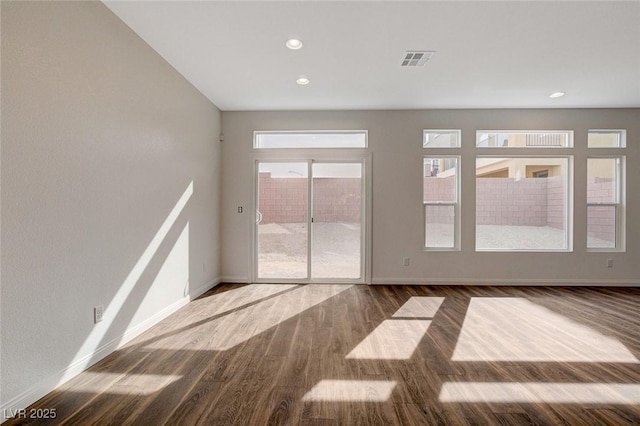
[255, 161, 364, 282]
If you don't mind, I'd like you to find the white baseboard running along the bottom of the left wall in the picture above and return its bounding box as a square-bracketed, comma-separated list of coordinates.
[0, 279, 221, 421]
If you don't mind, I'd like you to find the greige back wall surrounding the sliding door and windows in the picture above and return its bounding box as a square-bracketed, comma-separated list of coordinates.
[222, 109, 640, 285]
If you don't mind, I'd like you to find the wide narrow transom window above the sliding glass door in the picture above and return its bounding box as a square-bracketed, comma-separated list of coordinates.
[253, 131, 367, 149]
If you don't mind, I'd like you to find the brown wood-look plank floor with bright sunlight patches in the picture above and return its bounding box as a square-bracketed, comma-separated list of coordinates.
[7, 284, 640, 425]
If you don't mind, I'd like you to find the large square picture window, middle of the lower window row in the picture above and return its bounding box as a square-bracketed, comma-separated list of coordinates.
[476, 156, 571, 251]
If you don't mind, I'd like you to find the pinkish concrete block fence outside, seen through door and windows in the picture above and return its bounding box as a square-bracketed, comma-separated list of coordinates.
[259, 172, 615, 241]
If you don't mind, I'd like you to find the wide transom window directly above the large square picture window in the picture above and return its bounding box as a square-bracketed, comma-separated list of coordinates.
[476, 130, 573, 148]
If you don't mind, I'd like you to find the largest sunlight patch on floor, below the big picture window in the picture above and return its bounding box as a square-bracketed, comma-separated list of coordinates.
[451, 297, 639, 363]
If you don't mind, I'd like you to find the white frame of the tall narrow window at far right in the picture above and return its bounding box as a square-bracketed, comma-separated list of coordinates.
[585, 155, 626, 252]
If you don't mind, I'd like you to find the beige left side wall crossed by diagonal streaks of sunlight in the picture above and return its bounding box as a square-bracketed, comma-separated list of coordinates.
[0, 1, 220, 416]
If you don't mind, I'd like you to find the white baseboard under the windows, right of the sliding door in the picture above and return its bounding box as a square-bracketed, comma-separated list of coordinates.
[371, 277, 640, 287]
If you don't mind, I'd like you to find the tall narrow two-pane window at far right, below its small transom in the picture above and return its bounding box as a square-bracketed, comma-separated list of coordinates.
[587, 157, 624, 250]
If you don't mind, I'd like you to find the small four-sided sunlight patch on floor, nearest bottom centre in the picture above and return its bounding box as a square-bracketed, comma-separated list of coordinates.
[302, 380, 397, 402]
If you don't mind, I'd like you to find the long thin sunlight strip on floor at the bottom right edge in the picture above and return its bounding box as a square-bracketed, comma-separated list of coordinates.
[439, 382, 640, 405]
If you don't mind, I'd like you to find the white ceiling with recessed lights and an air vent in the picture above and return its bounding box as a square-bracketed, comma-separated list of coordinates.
[105, 0, 640, 111]
